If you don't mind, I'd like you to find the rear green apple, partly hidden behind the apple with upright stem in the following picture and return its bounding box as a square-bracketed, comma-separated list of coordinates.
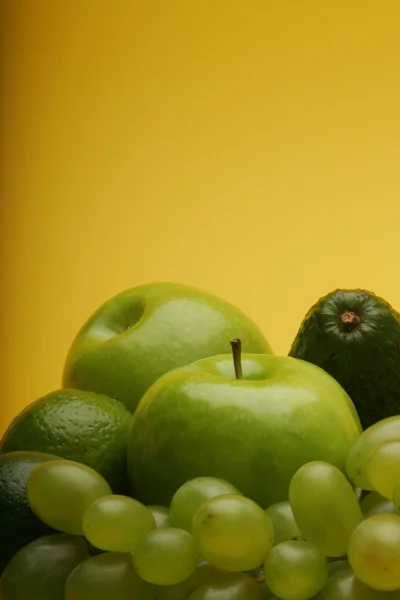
[63, 283, 272, 412]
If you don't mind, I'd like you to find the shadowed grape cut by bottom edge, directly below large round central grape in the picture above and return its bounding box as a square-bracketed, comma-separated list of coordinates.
[188, 573, 261, 600]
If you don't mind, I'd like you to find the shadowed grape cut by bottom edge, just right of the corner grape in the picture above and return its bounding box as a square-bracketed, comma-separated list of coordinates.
[65, 552, 154, 600]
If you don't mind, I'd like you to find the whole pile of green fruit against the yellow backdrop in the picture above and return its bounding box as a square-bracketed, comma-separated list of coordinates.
[0, 284, 400, 600]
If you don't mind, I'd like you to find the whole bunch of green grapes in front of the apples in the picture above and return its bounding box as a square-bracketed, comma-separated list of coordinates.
[0, 416, 400, 600]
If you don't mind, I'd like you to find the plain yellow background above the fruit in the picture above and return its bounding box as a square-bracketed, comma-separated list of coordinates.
[0, 0, 400, 429]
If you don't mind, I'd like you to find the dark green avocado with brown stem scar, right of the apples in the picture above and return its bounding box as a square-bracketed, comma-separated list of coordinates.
[289, 289, 400, 429]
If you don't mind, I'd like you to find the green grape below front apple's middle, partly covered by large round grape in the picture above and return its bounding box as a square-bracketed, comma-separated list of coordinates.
[170, 477, 241, 533]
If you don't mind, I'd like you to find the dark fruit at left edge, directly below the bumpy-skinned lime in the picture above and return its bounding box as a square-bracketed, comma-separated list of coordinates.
[0, 451, 56, 573]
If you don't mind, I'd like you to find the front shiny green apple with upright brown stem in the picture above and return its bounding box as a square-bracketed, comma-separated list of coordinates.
[128, 341, 361, 508]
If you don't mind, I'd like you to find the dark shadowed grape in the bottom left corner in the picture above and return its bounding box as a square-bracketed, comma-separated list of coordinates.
[0, 533, 90, 600]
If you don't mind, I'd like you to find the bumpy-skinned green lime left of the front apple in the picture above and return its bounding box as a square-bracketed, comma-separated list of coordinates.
[0, 389, 132, 492]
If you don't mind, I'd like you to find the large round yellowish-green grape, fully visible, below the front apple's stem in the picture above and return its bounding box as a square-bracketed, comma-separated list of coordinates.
[193, 495, 274, 571]
